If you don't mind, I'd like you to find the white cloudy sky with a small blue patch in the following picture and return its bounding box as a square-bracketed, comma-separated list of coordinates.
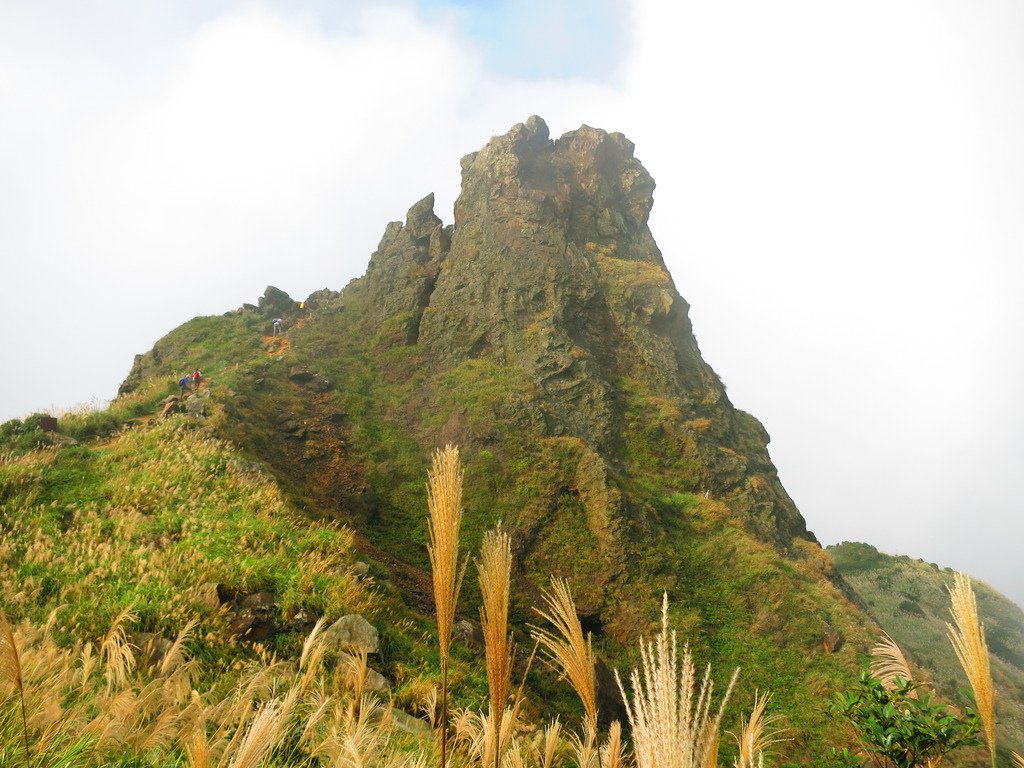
[0, 0, 1024, 603]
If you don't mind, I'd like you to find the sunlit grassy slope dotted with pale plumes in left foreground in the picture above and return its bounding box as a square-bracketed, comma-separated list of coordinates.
[0, 401, 507, 766]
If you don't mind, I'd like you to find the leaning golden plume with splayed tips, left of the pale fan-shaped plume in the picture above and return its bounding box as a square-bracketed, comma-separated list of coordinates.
[531, 577, 597, 743]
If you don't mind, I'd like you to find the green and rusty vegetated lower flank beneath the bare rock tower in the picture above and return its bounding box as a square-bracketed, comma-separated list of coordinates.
[88, 292, 888, 762]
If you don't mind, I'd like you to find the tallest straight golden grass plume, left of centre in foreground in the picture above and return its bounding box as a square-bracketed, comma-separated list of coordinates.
[427, 444, 466, 768]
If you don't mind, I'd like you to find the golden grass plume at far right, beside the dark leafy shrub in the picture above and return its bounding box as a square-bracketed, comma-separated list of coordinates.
[946, 572, 995, 768]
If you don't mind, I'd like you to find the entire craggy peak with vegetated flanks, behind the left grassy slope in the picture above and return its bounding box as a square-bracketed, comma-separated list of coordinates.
[116, 117, 873, 750]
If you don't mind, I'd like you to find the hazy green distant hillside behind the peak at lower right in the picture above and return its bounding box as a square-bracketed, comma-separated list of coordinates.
[828, 542, 1024, 760]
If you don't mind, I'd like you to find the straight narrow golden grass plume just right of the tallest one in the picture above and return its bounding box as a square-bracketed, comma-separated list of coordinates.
[476, 526, 512, 768]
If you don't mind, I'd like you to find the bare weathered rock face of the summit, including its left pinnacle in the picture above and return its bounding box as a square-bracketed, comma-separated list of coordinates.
[360, 117, 812, 547]
